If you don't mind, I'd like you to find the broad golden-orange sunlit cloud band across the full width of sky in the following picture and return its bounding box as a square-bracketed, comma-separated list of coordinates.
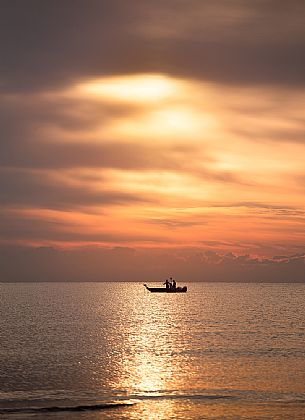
[0, 73, 305, 252]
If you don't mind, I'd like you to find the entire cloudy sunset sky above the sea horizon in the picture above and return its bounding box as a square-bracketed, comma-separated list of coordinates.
[0, 0, 305, 281]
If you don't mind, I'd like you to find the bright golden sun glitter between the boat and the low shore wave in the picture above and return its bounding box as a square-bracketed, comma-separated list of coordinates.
[107, 288, 191, 396]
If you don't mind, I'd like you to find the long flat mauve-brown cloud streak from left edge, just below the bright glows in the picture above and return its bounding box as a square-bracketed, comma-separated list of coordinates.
[0, 140, 201, 170]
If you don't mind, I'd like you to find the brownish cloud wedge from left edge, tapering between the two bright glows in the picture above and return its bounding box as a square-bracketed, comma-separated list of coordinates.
[0, 92, 140, 143]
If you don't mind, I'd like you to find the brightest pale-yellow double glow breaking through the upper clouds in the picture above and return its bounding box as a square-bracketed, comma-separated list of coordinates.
[73, 74, 217, 141]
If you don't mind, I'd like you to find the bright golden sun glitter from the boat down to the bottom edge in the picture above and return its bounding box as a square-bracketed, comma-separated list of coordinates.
[103, 290, 188, 420]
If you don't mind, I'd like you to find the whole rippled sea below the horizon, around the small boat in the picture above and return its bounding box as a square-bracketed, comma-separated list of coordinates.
[0, 282, 305, 420]
